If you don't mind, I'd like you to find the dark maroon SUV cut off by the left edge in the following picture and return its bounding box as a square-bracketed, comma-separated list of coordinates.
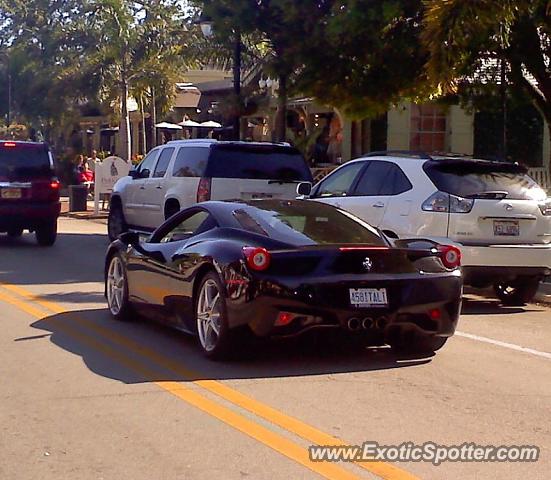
[0, 140, 60, 246]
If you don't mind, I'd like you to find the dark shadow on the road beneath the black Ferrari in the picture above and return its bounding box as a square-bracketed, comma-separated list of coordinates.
[27, 310, 431, 383]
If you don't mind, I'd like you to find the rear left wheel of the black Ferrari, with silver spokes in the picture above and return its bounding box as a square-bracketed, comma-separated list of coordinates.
[195, 272, 233, 359]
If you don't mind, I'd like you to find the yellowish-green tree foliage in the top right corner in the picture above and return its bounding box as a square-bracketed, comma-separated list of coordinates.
[422, 0, 551, 123]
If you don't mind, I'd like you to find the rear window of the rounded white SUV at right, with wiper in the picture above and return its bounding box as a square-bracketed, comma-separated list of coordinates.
[423, 160, 546, 200]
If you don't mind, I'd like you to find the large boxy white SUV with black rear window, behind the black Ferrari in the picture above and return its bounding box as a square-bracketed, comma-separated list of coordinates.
[108, 139, 312, 240]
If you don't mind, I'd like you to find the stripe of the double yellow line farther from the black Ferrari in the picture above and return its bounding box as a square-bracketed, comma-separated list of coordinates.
[0, 291, 366, 480]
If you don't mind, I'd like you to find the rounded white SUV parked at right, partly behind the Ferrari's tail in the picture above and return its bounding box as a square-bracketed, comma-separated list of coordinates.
[310, 152, 551, 305]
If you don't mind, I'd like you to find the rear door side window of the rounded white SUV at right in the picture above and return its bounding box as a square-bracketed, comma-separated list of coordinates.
[354, 161, 412, 196]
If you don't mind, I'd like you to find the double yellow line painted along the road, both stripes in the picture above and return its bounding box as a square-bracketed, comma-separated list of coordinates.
[0, 283, 417, 480]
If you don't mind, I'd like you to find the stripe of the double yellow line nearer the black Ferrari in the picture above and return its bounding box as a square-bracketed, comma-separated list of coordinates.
[0, 283, 418, 480]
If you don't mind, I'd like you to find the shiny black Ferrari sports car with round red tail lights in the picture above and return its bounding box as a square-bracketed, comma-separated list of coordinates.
[105, 200, 462, 358]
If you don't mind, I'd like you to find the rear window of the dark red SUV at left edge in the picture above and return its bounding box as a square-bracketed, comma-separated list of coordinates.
[0, 141, 53, 181]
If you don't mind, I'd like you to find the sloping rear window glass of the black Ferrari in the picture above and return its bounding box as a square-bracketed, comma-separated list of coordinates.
[233, 200, 387, 246]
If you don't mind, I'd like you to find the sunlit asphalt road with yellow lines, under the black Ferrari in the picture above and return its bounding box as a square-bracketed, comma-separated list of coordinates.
[0, 218, 551, 480]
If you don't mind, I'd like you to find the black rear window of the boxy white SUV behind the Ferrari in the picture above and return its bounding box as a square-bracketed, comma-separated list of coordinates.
[205, 145, 312, 182]
